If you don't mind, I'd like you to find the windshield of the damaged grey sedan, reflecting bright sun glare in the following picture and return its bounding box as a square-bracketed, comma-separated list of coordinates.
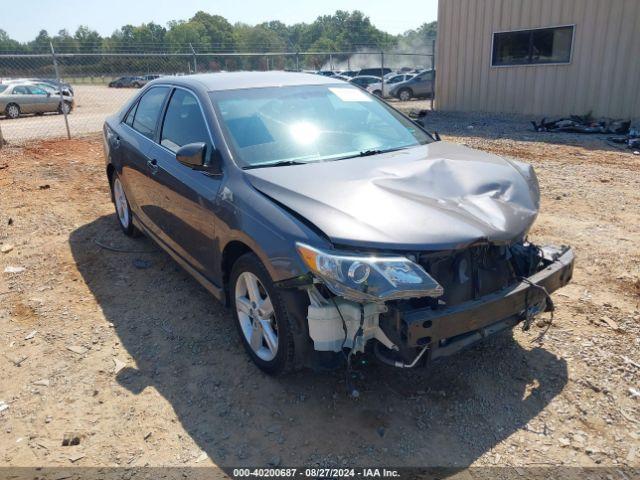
[210, 83, 432, 168]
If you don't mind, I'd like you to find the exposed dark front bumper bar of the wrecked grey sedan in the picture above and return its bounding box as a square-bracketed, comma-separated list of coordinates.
[396, 248, 574, 359]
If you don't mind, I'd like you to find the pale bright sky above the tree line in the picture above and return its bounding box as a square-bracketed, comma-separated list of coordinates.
[0, 0, 438, 42]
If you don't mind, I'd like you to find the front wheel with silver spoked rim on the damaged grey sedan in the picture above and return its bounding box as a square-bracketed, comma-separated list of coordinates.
[229, 253, 294, 375]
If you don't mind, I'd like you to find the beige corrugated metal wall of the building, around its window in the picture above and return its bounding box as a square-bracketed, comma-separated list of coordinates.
[436, 0, 640, 118]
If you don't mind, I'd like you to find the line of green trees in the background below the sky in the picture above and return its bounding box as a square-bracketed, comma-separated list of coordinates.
[0, 10, 437, 75]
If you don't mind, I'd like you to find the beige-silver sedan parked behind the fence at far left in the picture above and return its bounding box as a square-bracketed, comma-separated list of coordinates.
[0, 83, 73, 118]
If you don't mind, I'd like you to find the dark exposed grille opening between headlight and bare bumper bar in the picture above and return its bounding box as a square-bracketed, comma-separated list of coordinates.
[418, 244, 516, 306]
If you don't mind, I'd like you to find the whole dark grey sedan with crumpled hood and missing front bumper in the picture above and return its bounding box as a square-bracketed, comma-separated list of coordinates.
[104, 72, 574, 374]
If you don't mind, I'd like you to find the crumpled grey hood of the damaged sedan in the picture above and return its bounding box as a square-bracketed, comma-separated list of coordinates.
[245, 142, 539, 250]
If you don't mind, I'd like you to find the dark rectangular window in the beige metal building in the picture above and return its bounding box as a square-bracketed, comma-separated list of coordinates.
[491, 25, 574, 67]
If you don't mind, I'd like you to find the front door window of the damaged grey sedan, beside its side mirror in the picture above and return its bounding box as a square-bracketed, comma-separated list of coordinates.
[160, 89, 211, 152]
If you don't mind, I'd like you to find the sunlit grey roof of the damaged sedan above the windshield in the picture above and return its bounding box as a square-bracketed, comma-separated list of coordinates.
[152, 71, 336, 91]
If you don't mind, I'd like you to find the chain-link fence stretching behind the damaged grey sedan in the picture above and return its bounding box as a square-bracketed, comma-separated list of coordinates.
[0, 46, 435, 145]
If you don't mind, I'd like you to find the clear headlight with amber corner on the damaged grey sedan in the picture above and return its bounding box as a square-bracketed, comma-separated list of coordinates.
[296, 243, 444, 302]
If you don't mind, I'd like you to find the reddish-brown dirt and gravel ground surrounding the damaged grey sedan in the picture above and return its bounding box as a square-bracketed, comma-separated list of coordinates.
[0, 113, 640, 472]
